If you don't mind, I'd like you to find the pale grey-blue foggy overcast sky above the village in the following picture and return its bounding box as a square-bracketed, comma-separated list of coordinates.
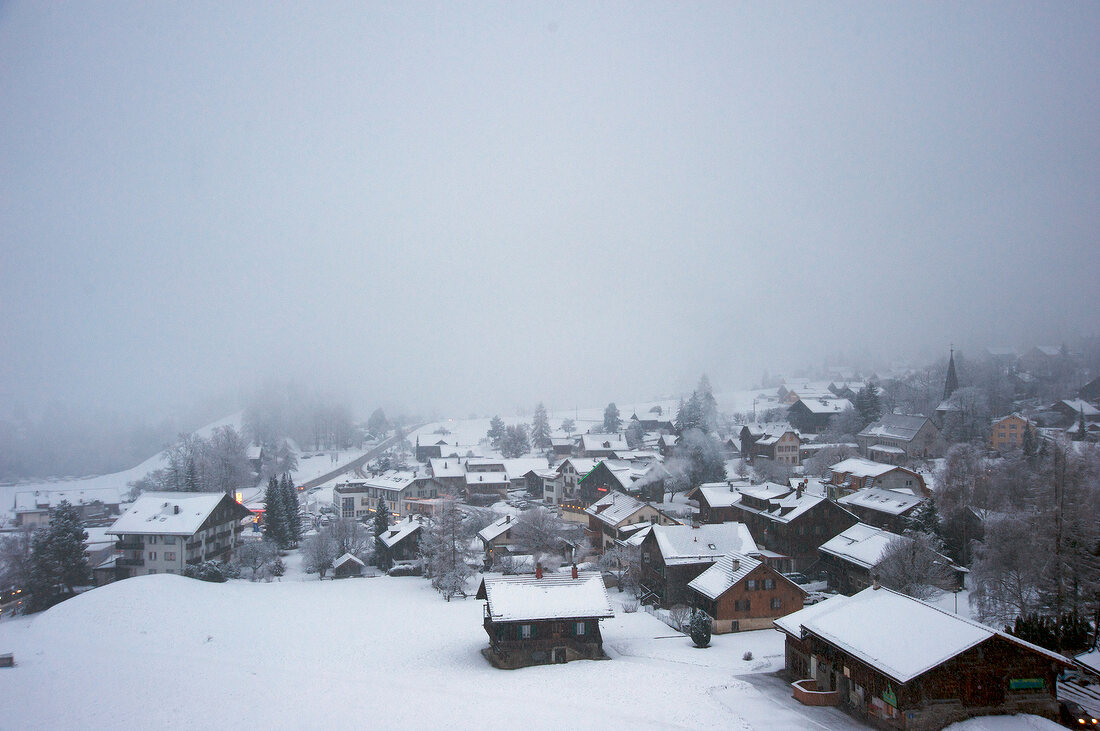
[0, 2, 1100, 414]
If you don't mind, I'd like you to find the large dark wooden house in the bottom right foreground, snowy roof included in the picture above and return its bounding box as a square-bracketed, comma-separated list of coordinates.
[774, 587, 1070, 731]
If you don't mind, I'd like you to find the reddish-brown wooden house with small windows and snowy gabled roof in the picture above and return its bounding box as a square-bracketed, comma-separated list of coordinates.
[688, 552, 806, 634]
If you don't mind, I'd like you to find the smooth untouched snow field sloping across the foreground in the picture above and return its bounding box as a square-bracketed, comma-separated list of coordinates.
[0, 554, 1057, 731]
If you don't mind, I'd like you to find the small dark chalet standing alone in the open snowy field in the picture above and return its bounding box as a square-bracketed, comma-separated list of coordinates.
[477, 566, 615, 668]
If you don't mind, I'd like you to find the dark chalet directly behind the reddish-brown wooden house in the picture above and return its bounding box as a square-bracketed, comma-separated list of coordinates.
[640, 523, 757, 608]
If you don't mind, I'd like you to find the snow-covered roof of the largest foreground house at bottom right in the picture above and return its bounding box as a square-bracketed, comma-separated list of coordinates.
[774, 587, 1069, 683]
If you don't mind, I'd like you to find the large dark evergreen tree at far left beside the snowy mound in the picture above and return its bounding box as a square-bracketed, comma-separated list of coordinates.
[28, 500, 91, 611]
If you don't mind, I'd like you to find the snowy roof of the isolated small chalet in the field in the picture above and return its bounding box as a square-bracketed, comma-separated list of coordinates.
[477, 572, 615, 622]
